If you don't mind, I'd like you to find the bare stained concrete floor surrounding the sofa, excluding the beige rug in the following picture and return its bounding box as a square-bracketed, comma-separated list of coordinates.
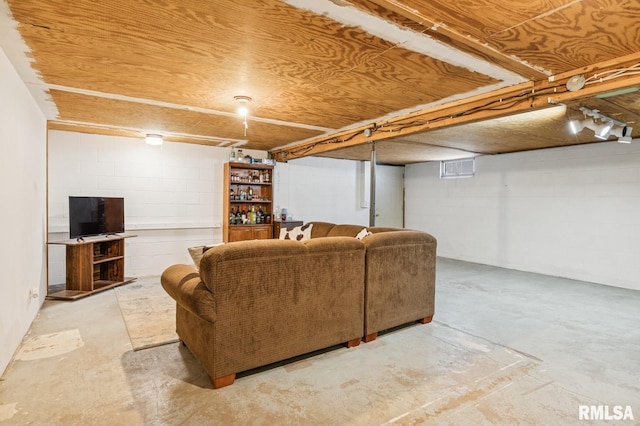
[0, 259, 640, 425]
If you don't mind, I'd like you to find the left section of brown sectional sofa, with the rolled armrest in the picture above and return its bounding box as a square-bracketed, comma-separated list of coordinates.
[161, 237, 365, 388]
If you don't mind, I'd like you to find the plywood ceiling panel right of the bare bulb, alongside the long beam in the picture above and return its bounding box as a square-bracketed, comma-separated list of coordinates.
[256, 44, 497, 128]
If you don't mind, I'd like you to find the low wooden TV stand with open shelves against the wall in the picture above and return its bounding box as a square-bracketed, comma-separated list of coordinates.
[47, 234, 135, 300]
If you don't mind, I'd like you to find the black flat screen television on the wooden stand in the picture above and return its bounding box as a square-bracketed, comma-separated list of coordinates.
[69, 196, 124, 238]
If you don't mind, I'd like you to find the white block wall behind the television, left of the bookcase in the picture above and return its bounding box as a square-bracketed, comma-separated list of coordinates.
[48, 131, 266, 285]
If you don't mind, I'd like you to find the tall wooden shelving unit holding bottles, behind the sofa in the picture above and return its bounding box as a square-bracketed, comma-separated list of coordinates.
[222, 162, 273, 242]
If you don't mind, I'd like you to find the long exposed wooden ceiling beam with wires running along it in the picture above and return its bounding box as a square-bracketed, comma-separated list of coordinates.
[271, 53, 640, 161]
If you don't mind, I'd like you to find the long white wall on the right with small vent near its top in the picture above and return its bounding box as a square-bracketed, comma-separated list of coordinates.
[405, 140, 640, 290]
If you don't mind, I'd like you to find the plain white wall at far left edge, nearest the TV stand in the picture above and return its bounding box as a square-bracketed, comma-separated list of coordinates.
[0, 49, 46, 372]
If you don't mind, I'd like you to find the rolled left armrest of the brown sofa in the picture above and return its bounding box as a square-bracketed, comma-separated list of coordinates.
[160, 265, 216, 322]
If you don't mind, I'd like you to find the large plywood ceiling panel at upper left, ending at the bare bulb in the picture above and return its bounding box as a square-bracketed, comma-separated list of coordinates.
[8, 0, 400, 115]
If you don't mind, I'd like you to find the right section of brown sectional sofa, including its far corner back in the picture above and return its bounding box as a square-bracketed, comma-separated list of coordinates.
[309, 222, 437, 342]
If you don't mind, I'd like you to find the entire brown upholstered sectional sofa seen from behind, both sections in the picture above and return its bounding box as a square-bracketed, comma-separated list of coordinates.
[161, 222, 436, 388]
